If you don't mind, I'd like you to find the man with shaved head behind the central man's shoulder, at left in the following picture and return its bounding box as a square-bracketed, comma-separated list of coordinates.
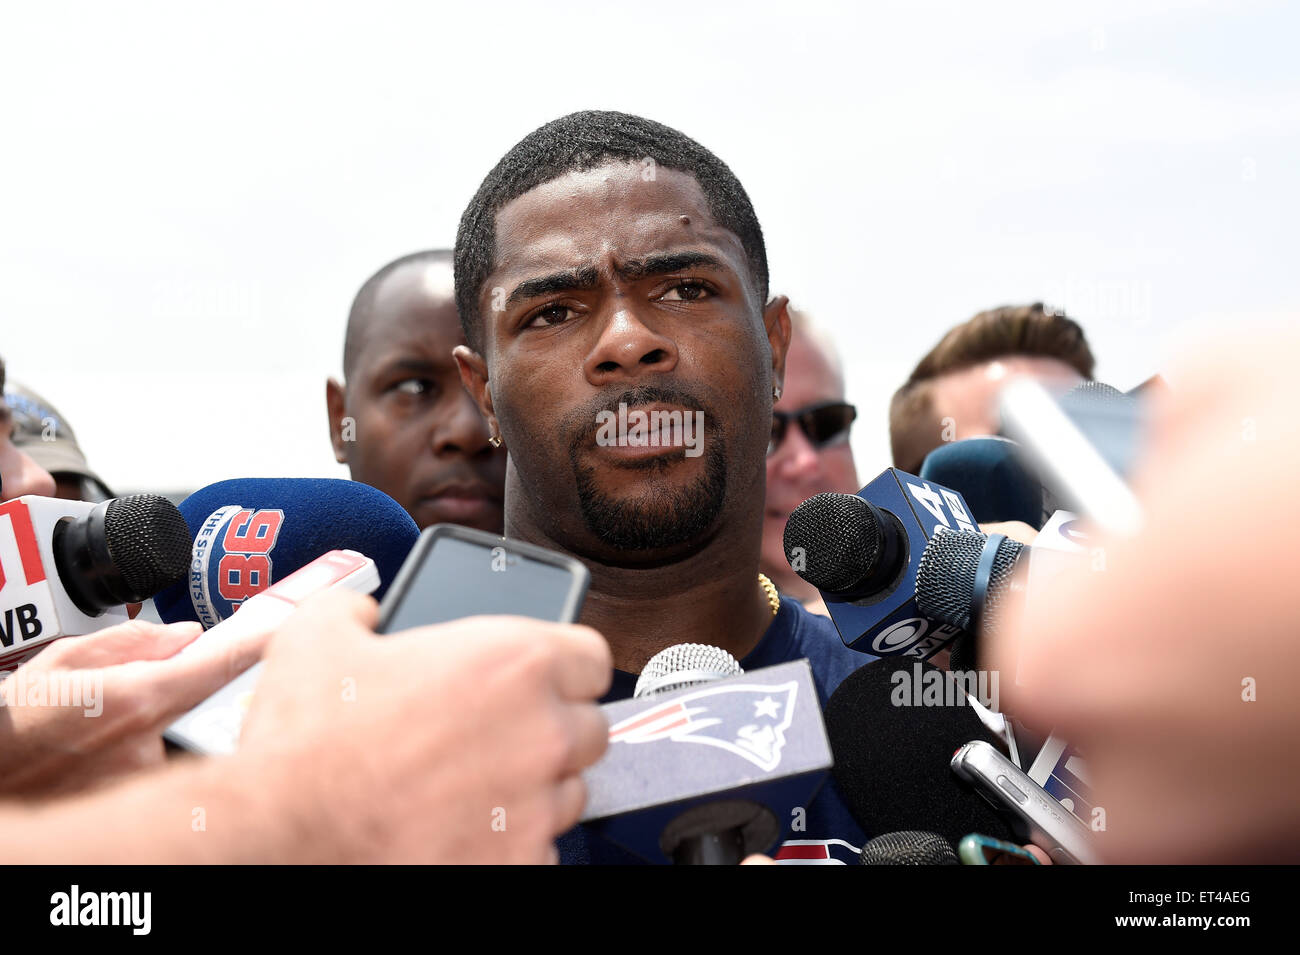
[325, 249, 506, 534]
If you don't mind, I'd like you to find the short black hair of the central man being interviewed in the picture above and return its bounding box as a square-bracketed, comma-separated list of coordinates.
[455, 109, 767, 351]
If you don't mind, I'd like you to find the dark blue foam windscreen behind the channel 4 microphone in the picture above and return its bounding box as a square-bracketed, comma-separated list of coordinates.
[918, 435, 1043, 529]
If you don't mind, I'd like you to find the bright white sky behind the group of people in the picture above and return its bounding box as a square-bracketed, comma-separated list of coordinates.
[0, 0, 1300, 489]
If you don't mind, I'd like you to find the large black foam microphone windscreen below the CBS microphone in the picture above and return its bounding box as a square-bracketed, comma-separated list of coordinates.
[826, 659, 1015, 846]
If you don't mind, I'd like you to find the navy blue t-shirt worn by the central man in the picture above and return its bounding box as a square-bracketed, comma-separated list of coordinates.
[555, 596, 876, 865]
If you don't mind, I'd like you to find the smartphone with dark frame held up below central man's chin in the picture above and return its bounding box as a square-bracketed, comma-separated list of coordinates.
[378, 524, 592, 633]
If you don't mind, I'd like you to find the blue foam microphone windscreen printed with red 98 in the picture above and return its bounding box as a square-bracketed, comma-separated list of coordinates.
[153, 478, 420, 628]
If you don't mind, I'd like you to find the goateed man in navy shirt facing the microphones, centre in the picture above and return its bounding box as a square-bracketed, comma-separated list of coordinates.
[455, 112, 872, 863]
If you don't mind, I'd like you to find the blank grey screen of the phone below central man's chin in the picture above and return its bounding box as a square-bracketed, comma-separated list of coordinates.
[384, 537, 573, 633]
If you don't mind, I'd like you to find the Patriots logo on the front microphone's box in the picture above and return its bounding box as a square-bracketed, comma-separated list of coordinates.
[610, 681, 798, 772]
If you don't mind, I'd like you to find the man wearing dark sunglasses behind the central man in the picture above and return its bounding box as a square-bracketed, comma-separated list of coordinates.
[759, 309, 861, 613]
